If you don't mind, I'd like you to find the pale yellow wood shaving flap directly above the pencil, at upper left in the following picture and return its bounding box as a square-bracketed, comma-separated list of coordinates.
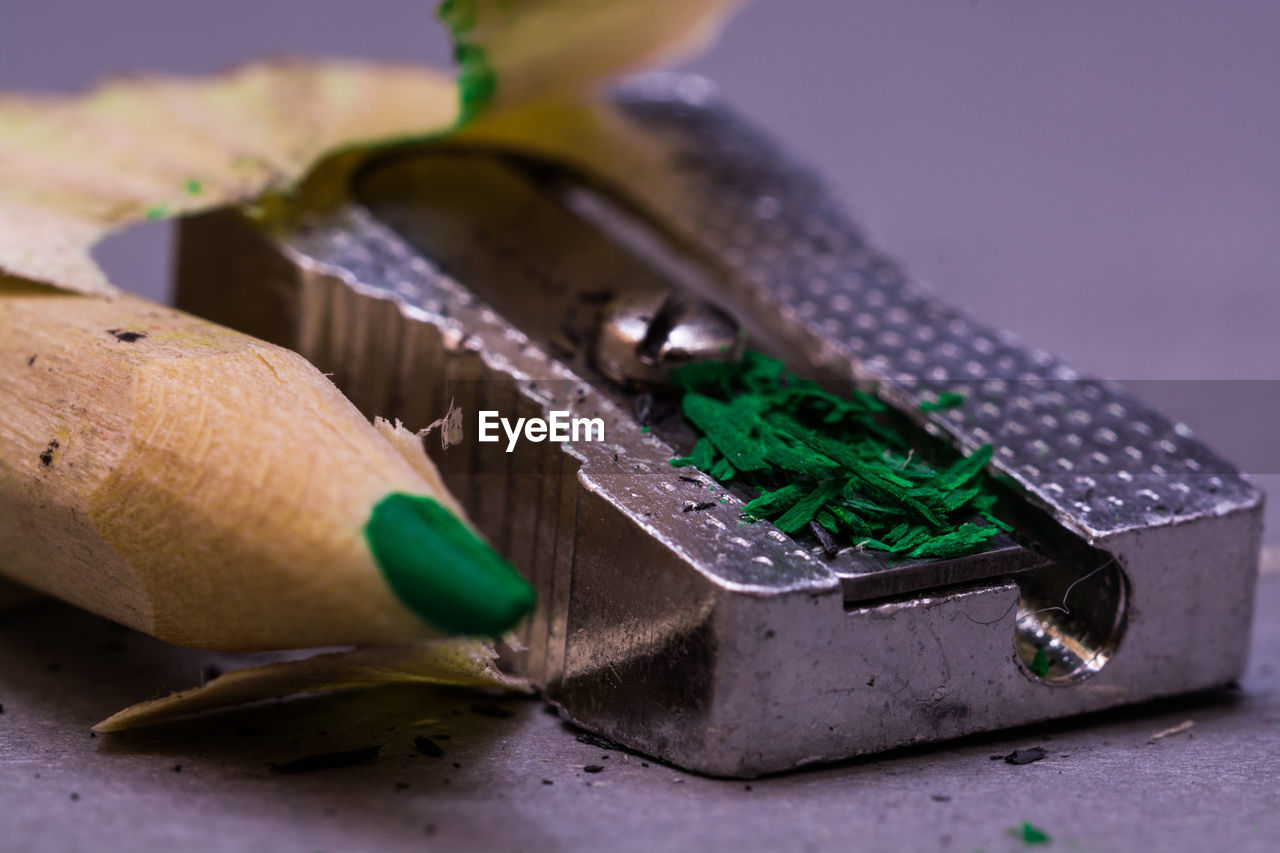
[0, 60, 456, 293]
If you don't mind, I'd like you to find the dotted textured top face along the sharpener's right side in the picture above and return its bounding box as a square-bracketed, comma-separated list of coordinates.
[614, 74, 1262, 540]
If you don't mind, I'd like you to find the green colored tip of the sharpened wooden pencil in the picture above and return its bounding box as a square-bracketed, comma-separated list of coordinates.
[365, 492, 534, 637]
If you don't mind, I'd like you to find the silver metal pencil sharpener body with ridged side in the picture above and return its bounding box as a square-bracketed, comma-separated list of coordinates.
[178, 74, 1262, 777]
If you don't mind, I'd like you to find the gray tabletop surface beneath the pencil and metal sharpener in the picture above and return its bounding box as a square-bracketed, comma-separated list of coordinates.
[0, 563, 1280, 853]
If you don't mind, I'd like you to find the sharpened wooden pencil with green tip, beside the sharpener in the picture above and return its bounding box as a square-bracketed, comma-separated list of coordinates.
[0, 277, 534, 651]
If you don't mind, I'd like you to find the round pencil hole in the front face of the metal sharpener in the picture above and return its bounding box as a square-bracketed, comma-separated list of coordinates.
[1014, 557, 1129, 685]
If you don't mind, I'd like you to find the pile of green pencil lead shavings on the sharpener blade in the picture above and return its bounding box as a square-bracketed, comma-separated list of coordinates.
[671, 351, 1010, 558]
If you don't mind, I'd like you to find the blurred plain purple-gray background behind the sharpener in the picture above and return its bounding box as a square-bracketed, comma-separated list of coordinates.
[0, 0, 1280, 542]
